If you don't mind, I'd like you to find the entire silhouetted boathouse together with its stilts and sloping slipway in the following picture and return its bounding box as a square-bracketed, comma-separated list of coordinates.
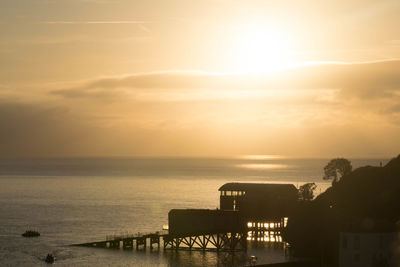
[73, 183, 297, 252]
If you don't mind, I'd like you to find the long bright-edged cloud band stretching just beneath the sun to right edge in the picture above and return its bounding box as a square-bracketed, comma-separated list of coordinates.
[52, 60, 400, 99]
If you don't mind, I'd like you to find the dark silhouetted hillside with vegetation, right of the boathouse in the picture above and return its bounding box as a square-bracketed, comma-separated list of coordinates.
[284, 156, 400, 264]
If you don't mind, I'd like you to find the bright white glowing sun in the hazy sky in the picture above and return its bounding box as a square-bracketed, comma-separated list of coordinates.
[231, 24, 292, 73]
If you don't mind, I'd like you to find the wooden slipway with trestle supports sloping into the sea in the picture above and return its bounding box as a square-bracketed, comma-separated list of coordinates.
[72, 231, 247, 252]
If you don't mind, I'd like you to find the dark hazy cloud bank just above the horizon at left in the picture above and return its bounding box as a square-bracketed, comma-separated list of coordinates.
[0, 96, 167, 158]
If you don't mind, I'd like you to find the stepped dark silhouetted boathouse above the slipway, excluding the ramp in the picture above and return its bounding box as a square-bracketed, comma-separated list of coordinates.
[168, 183, 298, 248]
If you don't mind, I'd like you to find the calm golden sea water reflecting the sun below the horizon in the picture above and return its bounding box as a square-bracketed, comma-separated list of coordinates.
[0, 157, 387, 266]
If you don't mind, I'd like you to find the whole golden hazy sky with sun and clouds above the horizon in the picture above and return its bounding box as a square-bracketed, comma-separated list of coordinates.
[0, 0, 400, 158]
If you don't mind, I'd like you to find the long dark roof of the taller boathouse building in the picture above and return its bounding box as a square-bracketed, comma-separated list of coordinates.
[218, 183, 297, 192]
